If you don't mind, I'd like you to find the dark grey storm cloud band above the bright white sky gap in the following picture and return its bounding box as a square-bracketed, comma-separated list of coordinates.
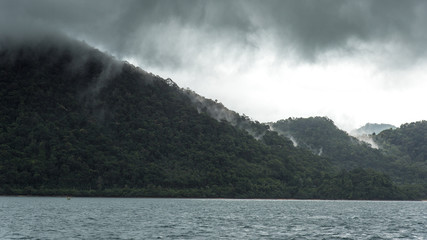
[0, 0, 427, 67]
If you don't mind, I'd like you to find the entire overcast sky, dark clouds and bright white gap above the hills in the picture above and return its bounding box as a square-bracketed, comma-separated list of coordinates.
[0, 0, 427, 131]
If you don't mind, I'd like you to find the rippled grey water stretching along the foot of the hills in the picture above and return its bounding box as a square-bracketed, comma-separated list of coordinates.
[0, 197, 427, 239]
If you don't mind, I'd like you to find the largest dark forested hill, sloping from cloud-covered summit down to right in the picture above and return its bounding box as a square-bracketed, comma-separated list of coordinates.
[0, 33, 414, 199]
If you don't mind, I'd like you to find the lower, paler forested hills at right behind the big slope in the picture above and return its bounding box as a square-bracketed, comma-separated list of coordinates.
[271, 117, 427, 198]
